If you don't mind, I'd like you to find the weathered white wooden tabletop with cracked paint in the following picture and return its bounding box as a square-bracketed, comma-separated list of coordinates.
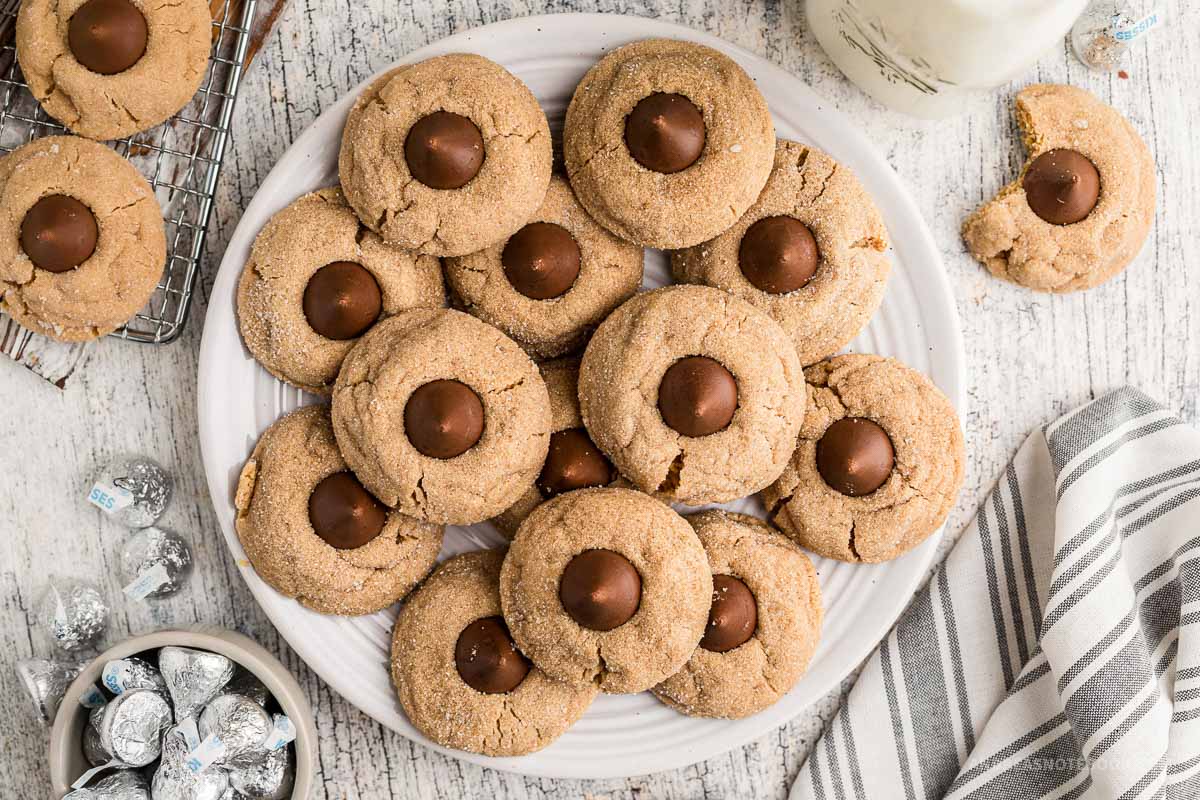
[0, 0, 1200, 799]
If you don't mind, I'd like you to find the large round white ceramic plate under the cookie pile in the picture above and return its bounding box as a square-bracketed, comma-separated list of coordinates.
[199, 14, 964, 778]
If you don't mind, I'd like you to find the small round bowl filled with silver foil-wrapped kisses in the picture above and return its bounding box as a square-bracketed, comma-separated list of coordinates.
[50, 627, 317, 800]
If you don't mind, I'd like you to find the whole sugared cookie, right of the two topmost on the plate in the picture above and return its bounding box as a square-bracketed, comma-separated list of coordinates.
[563, 40, 775, 248]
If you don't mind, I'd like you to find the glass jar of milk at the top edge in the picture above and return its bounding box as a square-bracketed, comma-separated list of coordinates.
[808, 0, 1087, 118]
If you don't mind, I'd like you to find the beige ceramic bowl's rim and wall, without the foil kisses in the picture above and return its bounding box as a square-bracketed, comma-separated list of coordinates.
[50, 626, 317, 800]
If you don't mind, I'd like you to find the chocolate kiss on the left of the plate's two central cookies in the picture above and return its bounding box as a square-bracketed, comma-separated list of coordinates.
[404, 380, 484, 459]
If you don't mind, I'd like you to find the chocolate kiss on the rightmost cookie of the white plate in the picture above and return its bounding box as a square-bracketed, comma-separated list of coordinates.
[817, 416, 895, 498]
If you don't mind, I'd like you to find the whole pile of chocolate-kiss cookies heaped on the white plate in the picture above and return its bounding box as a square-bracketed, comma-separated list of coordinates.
[236, 40, 962, 756]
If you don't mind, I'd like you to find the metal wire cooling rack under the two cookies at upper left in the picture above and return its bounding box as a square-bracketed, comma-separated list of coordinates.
[0, 0, 257, 344]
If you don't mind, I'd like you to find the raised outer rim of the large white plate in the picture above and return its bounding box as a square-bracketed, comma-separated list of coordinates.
[197, 12, 966, 780]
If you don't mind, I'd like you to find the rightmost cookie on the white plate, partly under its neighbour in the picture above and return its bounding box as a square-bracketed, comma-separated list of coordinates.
[762, 355, 964, 561]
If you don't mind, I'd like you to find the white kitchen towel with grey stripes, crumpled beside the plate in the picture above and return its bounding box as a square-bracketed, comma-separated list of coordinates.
[791, 389, 1200, 800]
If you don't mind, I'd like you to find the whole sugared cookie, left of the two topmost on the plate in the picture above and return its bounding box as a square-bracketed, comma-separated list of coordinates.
[337, 53, 551, 255]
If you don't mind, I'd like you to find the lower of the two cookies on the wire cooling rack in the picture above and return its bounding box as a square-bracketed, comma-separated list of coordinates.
[0, 137, 167, 342]
